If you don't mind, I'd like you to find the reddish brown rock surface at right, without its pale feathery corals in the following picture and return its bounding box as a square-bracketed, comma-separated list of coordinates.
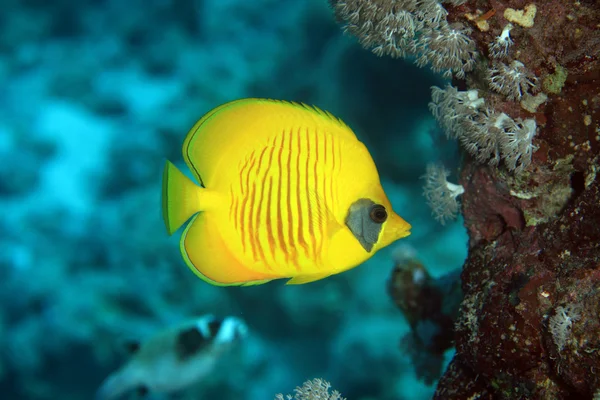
[435, 0, 600, 399]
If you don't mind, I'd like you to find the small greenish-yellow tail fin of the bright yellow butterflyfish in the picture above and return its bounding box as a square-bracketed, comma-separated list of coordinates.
[162, 161, 203, 235]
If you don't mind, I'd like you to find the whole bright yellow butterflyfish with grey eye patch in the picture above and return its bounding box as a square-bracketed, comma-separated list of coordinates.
[162, 99, 410, 286]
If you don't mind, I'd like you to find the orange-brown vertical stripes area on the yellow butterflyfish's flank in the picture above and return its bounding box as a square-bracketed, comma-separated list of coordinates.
[229, 127, 341, 274]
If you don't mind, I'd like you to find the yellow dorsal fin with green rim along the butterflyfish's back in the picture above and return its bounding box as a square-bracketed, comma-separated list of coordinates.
[182, 98, 357, 190]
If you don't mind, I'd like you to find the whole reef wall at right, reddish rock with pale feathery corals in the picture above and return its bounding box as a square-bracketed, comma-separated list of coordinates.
[333, 0, 600, 399]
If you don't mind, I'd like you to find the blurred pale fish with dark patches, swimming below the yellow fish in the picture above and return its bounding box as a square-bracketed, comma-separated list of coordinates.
[95, 315, 247, 400]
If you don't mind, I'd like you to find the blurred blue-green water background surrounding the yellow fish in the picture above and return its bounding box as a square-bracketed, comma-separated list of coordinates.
[0, 0, 468, 400]
